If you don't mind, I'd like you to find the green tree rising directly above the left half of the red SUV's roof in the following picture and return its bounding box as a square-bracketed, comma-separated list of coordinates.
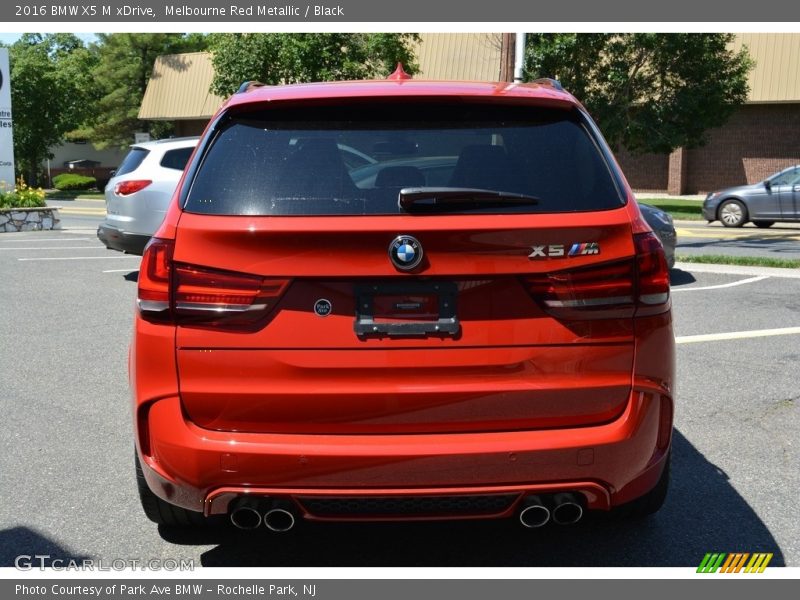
[210, 33, 419, 97]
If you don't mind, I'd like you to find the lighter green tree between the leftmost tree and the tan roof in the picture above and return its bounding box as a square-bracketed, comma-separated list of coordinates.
[84, 33, 206, 148]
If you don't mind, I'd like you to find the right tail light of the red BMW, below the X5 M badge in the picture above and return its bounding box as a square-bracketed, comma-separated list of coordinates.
[524, 232, 670, 319]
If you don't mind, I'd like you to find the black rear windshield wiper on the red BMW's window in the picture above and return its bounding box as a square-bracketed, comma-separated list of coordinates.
[397, 187, 539, 212]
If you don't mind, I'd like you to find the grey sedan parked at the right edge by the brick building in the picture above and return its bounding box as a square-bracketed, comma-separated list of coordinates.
[703, 165, 800, 227]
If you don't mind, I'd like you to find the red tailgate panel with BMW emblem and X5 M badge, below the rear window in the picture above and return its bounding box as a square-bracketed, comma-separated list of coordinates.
[174, 208, 634, 434]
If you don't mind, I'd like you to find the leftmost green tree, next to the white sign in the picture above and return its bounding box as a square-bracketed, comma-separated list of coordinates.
[9, 33, 96, 185]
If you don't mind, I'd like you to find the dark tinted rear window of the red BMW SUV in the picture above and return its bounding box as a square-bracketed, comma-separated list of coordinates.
[185, 103, 624, 215]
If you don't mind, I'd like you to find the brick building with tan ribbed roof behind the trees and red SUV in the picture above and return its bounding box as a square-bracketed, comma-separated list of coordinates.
[139, 33, 800, 194]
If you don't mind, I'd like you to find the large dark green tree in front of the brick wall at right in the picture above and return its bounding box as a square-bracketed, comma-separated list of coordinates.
[525, 33, 752, 153]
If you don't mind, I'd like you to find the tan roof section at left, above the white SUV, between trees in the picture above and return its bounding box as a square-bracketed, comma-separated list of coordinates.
[139, 52, 224, 121]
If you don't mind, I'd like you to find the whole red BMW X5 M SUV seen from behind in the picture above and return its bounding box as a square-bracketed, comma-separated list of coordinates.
[130, 75, 674, 531]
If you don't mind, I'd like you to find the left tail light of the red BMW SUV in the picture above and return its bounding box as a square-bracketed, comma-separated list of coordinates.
[137, 238, 289, 328]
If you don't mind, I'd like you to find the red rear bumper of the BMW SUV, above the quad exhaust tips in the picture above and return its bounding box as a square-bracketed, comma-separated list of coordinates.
[137, 390, 672, 518]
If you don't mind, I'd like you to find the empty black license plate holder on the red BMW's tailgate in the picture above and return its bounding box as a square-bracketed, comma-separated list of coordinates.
[353, 281, 461, 337]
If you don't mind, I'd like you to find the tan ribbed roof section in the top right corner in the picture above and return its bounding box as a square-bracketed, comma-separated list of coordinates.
[732, 33, 800, 104]
